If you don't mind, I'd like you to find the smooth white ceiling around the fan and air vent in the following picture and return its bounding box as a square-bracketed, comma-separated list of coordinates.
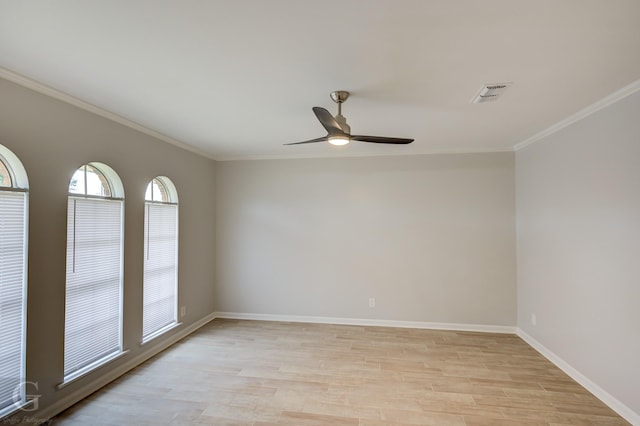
[0, 0, 640, 159]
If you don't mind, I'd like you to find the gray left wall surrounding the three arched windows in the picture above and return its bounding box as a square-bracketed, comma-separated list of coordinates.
[0, 79, 215, 416]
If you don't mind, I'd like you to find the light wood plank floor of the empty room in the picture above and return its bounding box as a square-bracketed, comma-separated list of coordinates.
[54, 319, 628, 426]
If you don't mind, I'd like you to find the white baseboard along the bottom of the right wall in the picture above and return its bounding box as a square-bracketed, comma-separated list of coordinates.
[516, 327, 640, 425]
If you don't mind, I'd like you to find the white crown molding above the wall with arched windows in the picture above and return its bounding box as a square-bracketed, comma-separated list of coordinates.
[0, 67, 215, 160]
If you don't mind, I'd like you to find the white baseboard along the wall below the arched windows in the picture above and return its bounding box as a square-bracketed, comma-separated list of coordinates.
[31, 314, 216, 421]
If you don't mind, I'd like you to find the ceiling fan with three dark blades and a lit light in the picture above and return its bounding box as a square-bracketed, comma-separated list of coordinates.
[285, 90, 413, 145]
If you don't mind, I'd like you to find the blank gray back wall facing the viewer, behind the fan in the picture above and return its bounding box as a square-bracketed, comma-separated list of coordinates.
[215, 153, 516, 326]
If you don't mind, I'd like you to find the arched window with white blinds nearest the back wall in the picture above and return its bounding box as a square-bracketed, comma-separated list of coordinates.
[142, 176, 178, 342]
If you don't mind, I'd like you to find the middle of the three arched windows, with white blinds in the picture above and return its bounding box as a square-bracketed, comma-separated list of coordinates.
[64, 163, 124, 383]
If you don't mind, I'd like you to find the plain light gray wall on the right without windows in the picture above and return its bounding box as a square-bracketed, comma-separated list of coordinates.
[516, 89, 640, 413]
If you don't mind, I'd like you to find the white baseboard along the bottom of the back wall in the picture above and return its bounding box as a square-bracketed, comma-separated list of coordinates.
[215, 312, 516, 334]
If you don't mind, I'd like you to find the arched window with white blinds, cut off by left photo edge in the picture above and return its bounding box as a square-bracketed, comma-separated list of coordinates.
[0, 145, 29, 418]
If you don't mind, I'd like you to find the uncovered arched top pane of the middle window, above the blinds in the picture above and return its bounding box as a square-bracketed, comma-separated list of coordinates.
[69, 162, 124, 198]
